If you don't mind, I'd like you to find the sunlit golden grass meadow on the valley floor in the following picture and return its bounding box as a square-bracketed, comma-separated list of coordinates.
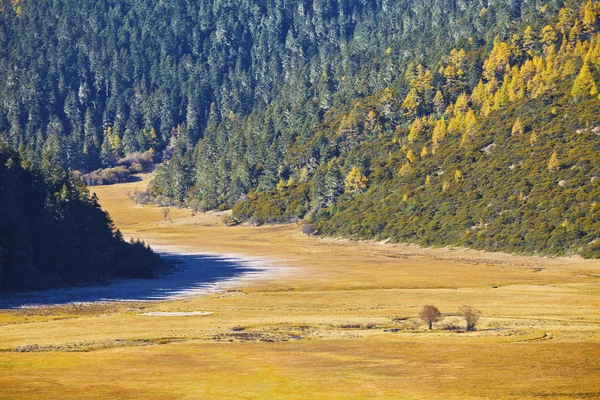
[0, 176, 600, 399]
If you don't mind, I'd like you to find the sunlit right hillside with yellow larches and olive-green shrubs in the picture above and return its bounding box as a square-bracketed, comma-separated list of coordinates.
[229, 2, 600, 257]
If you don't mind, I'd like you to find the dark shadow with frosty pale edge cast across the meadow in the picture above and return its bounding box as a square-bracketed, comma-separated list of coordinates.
[0, 253, 265, 309]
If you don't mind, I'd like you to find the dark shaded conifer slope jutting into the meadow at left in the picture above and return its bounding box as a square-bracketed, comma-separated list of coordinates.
[0, 144, 160, 292]
